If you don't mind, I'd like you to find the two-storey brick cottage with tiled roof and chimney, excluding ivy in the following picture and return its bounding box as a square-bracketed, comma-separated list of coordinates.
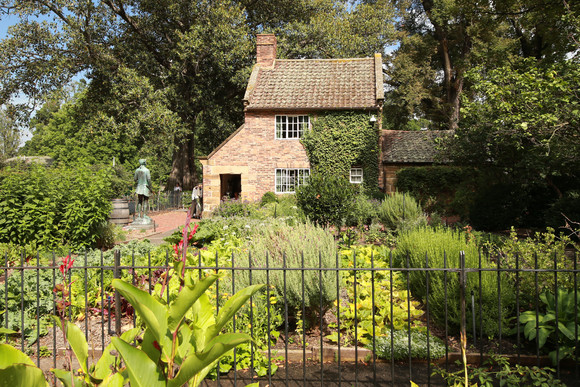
[200, 34, 444, 216]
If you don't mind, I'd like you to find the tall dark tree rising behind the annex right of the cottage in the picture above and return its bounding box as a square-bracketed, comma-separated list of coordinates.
[387, 0, 580, 129]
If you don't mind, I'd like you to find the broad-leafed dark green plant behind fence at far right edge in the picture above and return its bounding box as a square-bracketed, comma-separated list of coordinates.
[519, 289, 580, 365]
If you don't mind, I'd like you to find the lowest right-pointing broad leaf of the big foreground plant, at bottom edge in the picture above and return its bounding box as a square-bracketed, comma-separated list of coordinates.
[167, 333, 251, 387]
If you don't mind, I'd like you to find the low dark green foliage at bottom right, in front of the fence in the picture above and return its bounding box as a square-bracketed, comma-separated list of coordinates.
[433, 354, 566, 387]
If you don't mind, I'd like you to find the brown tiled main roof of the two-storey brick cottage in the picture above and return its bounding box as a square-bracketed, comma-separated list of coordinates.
[244, 54, 384, 110]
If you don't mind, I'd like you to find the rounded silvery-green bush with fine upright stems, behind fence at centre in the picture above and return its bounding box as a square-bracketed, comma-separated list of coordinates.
[242, 223, 337, 322]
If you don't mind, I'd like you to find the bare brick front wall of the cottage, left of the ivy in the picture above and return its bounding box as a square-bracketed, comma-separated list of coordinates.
[202, 111, 310, 215]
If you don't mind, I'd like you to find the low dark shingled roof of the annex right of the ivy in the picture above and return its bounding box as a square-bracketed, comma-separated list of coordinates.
[382, 130, 452, 164]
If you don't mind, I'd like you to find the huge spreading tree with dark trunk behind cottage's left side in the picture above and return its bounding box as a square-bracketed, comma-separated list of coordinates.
[0, 0, 392, 188]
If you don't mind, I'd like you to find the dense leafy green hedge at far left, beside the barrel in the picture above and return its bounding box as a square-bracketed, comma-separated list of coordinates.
[0, 165, 111, 248]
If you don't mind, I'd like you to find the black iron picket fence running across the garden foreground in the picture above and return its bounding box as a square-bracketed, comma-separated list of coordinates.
[0, 251, 580, 386]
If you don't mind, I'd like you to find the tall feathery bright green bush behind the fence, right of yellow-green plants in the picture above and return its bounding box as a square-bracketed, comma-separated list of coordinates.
[394, 228, 515, 337]
